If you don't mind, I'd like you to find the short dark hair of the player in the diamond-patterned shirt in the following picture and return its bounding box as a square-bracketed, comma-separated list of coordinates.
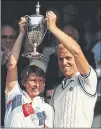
[21, 65, 45, 85]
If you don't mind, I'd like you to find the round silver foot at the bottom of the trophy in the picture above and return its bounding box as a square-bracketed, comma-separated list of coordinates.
[22, 52, 43, 59]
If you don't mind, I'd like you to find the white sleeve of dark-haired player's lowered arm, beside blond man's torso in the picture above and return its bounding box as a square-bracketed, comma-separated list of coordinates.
[45, 104, 54, 128]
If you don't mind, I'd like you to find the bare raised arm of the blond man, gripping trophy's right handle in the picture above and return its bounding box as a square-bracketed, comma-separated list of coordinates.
[46, 11, 89, 75]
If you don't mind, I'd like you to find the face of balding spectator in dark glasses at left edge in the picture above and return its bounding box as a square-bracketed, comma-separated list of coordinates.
[1, 26, 16, 50]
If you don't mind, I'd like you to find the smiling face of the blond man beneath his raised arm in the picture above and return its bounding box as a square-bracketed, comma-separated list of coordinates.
[57, 44, 78, 77]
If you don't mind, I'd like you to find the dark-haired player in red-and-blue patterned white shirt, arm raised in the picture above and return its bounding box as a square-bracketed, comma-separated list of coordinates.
[5, 17, 53, 128]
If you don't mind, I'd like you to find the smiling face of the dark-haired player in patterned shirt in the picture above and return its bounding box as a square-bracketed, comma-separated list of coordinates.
[24, 73, 45, 98]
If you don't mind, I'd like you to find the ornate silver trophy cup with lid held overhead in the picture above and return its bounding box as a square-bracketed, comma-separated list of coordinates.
[24, 2, 47, 59]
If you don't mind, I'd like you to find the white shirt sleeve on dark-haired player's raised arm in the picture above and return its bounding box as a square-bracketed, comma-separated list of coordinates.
[5, 81, 22, 103]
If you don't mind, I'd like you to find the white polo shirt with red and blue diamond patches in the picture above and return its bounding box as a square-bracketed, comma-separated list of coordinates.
[4, 83, 53, 128]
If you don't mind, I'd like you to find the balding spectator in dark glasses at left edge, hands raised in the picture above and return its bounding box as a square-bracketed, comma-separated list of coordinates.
[1, 24, 17, 65]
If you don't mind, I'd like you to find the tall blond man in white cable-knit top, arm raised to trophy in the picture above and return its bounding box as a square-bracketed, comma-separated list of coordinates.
[46, 11, 97, 128]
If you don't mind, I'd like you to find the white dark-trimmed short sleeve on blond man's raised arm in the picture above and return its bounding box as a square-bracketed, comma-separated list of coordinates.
[79, 67, 97, 95]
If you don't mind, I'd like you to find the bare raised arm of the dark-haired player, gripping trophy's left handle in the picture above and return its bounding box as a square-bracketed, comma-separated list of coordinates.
[6, 17, 26, 92]
